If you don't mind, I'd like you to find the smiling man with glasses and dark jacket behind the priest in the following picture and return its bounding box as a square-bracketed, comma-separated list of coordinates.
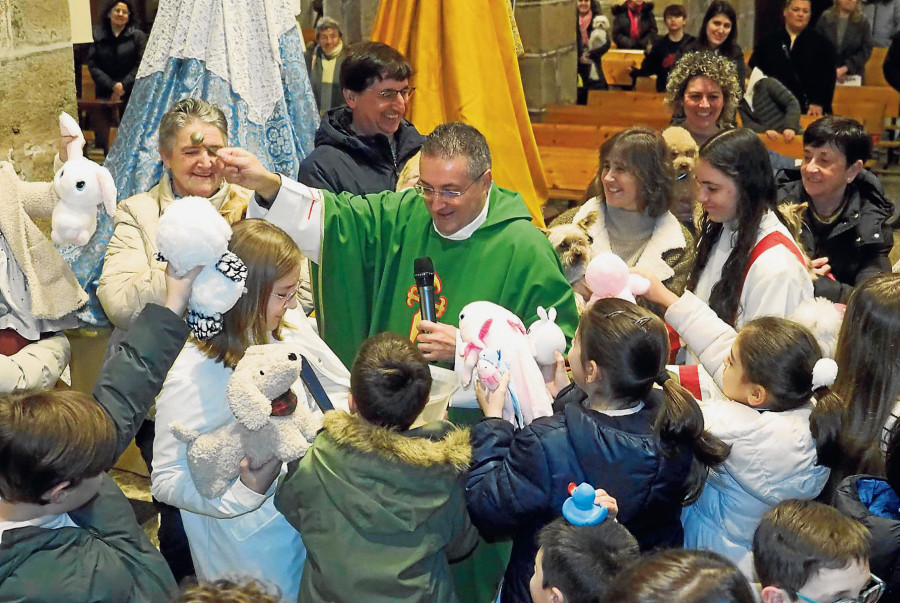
[297, 42, 425, 195]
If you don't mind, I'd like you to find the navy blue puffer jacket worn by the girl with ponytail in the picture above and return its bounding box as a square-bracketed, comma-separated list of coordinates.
[466, 385, 693, 603]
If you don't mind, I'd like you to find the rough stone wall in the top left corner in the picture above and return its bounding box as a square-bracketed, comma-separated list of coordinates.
[0, 0, 76, 180]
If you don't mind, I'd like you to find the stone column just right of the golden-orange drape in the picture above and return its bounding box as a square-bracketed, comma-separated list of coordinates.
[515, 0, 577, 121]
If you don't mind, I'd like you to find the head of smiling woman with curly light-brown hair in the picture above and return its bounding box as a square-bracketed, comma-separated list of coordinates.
[666, 51, 741, 144]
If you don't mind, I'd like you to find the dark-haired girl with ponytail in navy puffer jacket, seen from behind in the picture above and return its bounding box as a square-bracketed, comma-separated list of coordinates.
[466, 298, 728, 602]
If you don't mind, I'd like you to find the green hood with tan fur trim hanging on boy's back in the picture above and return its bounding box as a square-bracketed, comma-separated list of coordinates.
[275, 410, 472, 537]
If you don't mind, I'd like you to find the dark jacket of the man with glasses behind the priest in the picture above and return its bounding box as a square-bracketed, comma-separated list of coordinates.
[297, 107, 425, 195]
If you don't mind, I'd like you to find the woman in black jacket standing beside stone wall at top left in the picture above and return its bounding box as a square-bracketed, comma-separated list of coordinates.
[87, 0, 147, 149]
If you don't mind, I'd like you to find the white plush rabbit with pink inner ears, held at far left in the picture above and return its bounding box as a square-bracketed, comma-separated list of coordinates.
[50, 112, 117, 246]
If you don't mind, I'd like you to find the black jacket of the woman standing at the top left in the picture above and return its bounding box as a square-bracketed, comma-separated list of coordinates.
[87, 23, 147, 100]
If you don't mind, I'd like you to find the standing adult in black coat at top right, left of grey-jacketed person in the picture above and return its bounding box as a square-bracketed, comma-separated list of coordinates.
[750, 0, 837, 116]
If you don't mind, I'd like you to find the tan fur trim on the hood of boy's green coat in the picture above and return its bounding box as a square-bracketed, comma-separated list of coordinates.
[323, 410, 472, 473]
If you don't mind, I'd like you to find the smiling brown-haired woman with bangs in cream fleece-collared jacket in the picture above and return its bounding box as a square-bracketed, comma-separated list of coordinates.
[573, 127, 694, 316]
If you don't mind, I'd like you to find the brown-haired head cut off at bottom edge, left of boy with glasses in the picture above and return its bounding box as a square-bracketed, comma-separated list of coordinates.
[605, 549, 760, 603]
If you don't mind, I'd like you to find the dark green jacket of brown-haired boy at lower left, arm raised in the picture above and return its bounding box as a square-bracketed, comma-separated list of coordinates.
[0, 305, 188, 603]
